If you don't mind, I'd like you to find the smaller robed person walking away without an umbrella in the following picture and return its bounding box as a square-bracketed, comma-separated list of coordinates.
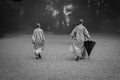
[32, 23, 46, 59]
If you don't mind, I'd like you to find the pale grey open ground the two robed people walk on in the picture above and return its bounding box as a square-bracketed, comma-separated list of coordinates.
[0, 34, 120, 80]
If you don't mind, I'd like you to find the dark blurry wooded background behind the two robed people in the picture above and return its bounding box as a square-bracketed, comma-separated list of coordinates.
[0, 0, 120, 36]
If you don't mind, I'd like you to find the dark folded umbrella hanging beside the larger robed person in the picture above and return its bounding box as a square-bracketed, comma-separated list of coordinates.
[84, 40, 96, 56]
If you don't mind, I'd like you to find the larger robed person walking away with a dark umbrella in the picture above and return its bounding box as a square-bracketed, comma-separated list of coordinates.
[70, 19, 90, 60]
